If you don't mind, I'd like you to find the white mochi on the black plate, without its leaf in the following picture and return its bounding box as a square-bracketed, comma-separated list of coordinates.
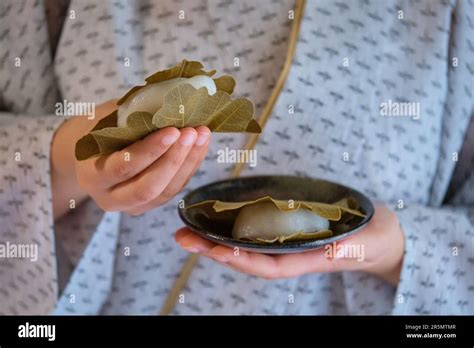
[232, 202, 329, 240]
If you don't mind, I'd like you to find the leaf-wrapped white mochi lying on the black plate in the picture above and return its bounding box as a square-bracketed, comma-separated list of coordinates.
[186, 196, 365, 243]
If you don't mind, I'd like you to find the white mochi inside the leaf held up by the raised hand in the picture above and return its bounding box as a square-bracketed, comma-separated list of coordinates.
[117, 75, 217, 127]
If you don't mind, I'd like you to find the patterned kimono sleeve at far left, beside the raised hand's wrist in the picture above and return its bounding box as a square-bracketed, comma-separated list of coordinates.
[0, 1, 63, 314]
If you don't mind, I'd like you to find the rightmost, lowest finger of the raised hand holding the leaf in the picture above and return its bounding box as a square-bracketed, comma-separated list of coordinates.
[127, 127, 211, 215]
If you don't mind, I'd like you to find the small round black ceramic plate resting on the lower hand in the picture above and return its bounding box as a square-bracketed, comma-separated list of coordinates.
[178, 175, 374, 254]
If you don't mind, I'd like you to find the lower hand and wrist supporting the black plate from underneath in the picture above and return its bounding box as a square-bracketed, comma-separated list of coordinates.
[175, 205, 404, 286]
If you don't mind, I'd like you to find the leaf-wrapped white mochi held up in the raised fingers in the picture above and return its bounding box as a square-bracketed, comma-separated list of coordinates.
[76, 60, 261, 160]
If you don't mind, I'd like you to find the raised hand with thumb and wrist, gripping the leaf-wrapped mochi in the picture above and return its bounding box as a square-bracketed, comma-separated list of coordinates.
[51, 100, 211, 219]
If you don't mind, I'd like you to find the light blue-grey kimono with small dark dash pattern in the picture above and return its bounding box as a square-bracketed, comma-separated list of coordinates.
[0, 0, 474, 314]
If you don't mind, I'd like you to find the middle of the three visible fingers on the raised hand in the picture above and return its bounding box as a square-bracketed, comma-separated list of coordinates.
[109, 128, 197, 210]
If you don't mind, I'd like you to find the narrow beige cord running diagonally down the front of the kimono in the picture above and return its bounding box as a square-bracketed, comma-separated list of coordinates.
[160, 0, 305, 315]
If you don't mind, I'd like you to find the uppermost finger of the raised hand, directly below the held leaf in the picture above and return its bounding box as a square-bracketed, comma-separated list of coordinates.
[94, 127, 181, 188]
